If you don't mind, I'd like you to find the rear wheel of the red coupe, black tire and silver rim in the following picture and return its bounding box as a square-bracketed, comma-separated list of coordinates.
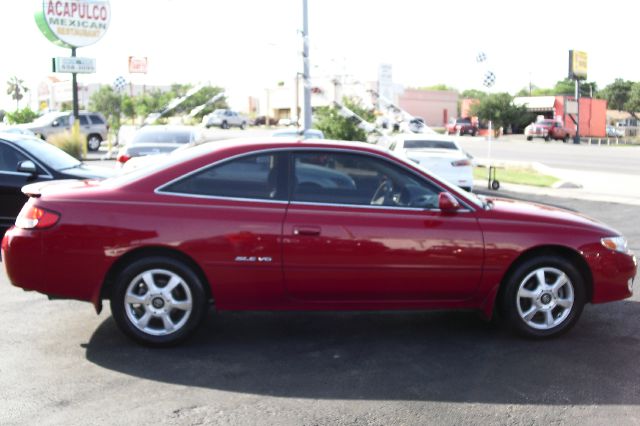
[110, 256, 207, 346]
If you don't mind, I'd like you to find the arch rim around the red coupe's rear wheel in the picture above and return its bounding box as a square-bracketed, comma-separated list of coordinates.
[95, 246, 213, 312]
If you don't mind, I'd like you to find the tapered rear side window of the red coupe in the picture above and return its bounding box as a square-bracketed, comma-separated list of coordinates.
[162, 154, 286, 200]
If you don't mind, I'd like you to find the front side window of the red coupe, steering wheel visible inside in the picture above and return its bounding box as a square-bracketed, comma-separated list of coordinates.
[291, 151, 439, 209]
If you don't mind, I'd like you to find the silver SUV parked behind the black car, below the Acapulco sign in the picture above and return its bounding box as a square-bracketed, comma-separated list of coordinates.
[21, 111, 109, 151]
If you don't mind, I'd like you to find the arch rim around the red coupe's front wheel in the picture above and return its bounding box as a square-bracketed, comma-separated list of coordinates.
[494, 245, 593, 311]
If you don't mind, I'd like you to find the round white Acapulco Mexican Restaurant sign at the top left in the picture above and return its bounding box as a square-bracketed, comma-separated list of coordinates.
[36, 0, 111, 47]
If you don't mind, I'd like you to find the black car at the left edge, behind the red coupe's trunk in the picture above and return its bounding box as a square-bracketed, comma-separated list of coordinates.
[0, 133, 116, 235]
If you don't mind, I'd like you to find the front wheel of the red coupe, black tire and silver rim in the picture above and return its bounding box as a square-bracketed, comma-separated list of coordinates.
[500, 256, 586, 339]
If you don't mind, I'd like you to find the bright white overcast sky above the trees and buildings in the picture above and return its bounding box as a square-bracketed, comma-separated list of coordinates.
[0, 0, 640, 111]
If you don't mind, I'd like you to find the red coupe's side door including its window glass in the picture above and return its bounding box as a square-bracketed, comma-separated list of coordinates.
[283, 150, 484, 302]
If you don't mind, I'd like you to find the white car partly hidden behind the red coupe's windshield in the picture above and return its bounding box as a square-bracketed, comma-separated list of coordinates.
[389, 134, 473, 191]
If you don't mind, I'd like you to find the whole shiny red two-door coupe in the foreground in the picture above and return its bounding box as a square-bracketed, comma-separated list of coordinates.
[2, 140, 637, 345]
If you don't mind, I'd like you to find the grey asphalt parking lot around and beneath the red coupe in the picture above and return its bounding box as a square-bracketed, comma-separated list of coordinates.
[0, 195, 640, 425]
